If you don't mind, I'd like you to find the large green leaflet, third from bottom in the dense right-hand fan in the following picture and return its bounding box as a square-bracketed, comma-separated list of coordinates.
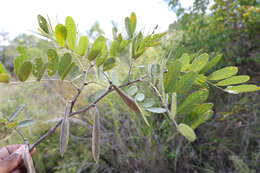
[177, 89, 209, 115]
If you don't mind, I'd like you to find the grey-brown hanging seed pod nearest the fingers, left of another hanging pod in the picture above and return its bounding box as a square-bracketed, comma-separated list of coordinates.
[60, 102, 70, 157]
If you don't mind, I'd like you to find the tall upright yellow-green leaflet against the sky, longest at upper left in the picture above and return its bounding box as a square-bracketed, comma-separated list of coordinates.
[65, 16, 77, 50]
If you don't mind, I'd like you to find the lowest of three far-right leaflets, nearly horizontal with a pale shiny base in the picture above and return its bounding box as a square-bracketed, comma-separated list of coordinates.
[225, 84, 260, 94]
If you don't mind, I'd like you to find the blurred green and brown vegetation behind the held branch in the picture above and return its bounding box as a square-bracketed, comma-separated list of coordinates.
[0, 0, 260, 173]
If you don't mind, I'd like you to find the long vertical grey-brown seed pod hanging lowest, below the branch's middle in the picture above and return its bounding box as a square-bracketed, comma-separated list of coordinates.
[92, 107, 100, 162]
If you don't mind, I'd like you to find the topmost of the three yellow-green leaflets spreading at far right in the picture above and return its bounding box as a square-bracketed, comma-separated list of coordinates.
[208, 66, 238, 81]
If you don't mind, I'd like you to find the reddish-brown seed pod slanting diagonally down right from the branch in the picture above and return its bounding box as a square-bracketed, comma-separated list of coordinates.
[113, 85, 141, 113]
